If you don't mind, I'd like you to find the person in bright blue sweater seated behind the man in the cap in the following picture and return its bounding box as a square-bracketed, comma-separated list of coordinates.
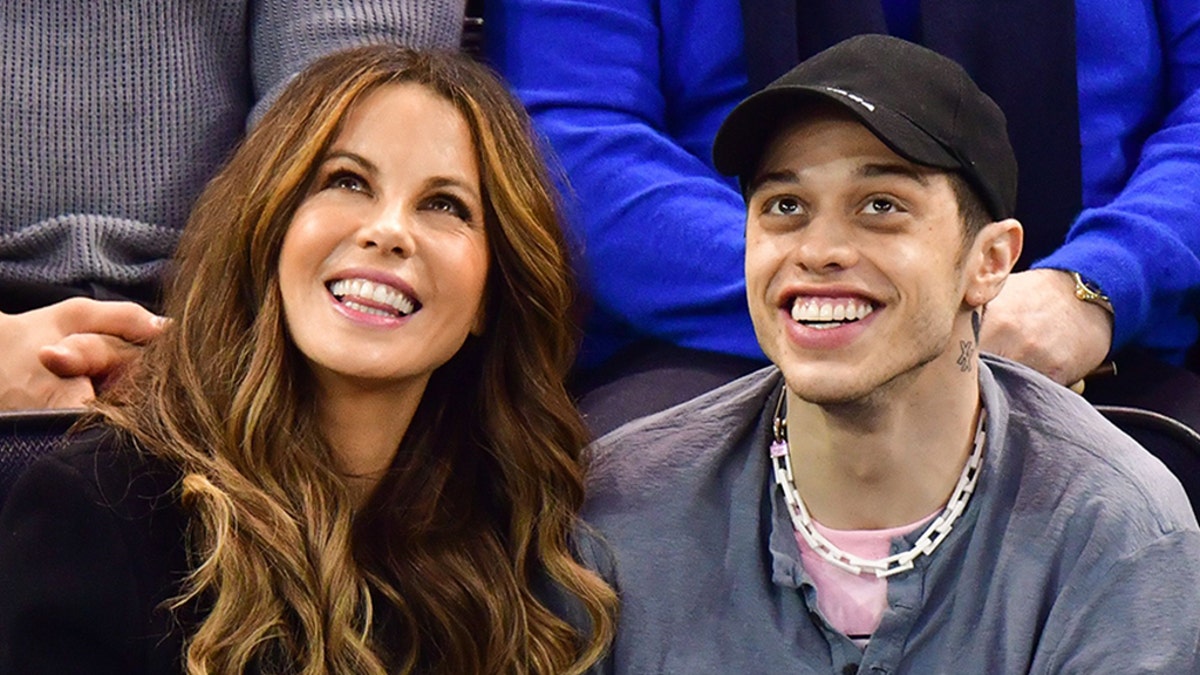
[486, 0, 1200, 431]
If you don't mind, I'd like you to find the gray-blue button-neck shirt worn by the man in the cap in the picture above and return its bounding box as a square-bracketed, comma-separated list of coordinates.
[584, 357, 1200, 675]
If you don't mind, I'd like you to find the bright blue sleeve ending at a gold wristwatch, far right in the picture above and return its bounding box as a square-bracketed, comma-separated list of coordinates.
[1033, 0, 1200, 360]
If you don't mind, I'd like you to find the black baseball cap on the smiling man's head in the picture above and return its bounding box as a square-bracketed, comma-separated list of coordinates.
[713, 35, 1016, 220]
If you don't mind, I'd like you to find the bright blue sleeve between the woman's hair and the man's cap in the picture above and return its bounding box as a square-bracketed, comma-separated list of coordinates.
[486, 0, 762, 359]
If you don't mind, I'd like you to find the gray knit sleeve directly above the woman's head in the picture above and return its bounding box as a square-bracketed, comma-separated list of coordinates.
[250, 0, 466, 120]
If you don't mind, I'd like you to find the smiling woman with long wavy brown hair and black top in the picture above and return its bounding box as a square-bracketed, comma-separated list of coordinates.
[0, 47, 616, 674]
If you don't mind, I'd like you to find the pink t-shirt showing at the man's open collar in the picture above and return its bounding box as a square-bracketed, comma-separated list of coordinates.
[796, 509, 941, 647]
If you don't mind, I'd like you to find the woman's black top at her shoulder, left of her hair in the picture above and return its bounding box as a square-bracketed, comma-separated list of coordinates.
[0, 429, 192, 675]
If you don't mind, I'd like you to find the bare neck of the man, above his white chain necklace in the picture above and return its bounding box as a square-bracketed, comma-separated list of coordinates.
[785, 348, 979, 530]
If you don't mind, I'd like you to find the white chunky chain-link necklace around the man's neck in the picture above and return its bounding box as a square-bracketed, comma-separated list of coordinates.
[770, 386, 988, 579]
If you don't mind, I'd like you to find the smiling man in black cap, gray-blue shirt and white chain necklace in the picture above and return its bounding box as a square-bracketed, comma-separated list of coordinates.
[584, 36, 1200, 674]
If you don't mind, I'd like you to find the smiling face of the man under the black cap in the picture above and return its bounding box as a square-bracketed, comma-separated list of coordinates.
[745, 108, 970, 405]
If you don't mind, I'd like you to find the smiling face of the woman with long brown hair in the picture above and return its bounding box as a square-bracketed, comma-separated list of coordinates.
[278, 84, 488, 398]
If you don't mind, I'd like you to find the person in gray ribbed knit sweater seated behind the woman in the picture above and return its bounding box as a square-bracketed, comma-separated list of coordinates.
[0, 0, 464, 410]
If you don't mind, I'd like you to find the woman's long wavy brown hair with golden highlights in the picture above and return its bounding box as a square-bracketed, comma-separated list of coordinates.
[98, 47, 616, 674]
